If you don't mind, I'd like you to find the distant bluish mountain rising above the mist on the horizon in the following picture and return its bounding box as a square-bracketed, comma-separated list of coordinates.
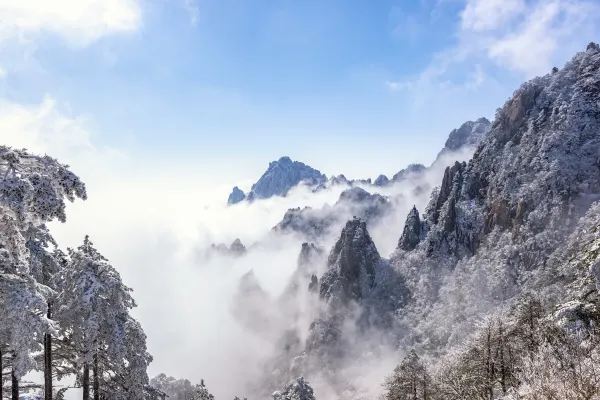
[228, 157, 327, 204]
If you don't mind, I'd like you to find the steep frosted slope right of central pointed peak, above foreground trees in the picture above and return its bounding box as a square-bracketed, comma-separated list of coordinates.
[392, 45, 600, 349]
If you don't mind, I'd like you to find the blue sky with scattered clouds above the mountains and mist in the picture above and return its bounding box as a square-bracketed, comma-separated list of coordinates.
[0, 0, 598, 181]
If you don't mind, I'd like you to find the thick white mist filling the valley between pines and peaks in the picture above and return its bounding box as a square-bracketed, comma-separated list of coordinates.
[2, 117, 470, 399]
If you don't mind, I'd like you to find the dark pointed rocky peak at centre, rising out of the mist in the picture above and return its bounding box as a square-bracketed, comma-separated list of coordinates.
[320, 218, 381, 306]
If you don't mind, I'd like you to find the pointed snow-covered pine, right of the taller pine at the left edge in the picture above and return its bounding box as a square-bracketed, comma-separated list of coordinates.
[55, 236, 151, 400]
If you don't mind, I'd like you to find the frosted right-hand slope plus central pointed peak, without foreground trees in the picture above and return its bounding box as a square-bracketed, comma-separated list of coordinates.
[255, 44, 600, 400]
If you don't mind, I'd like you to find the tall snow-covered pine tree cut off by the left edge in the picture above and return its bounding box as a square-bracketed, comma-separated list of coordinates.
[0, 146, 87, 399]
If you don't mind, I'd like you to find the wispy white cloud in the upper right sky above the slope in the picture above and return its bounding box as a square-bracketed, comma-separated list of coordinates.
[394, 0, 600, 104]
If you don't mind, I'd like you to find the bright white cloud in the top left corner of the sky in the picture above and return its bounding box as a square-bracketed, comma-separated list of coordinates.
[0, 0, 141, 46]
